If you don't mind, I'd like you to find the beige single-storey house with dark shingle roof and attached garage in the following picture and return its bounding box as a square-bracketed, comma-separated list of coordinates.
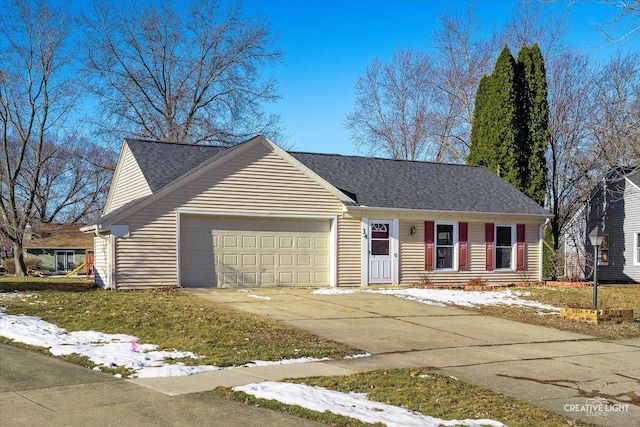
[82, 136, 549, 289]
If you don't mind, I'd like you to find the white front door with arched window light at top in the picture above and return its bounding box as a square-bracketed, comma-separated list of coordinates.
[369, 220, 393, 283]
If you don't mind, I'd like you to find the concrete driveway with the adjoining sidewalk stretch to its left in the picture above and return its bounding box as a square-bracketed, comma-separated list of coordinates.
[131, 289, 640, 426]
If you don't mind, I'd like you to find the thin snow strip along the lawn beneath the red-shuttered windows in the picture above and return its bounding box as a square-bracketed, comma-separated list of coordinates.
[313, 288, 560, 311]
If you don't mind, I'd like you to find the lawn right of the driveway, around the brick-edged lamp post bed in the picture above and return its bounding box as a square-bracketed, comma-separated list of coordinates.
[462, 285, 640, 340]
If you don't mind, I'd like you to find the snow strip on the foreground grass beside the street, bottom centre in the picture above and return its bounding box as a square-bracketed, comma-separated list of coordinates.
[233, 381, 504, 427]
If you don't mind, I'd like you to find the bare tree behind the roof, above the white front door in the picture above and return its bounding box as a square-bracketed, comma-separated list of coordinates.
[345, 48, 439, 160]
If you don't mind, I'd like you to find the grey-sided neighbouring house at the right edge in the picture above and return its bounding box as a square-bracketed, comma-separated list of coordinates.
[561, 168, 640, 283]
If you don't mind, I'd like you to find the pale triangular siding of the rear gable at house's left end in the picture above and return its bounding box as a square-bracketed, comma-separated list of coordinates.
[103, 143, 151, 215]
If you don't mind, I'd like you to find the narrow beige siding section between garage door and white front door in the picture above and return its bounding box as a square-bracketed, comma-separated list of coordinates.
[338, 217, 362, 286]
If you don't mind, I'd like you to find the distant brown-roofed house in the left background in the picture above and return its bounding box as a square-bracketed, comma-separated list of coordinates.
[24, 224, 93, 273]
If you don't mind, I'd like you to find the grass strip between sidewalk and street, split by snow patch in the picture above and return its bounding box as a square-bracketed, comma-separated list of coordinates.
[212, 369, 591, 427]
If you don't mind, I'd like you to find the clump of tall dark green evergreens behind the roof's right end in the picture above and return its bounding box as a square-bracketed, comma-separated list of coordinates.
[467, 44, 549, 204]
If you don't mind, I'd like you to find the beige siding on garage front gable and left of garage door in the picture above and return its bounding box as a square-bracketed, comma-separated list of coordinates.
[110, 145, 342, 288]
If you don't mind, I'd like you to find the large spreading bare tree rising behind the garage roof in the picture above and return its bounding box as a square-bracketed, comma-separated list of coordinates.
[84, 0, 282, 144]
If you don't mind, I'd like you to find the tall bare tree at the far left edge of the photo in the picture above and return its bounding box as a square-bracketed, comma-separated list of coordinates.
[0, 0, 76, 275]
